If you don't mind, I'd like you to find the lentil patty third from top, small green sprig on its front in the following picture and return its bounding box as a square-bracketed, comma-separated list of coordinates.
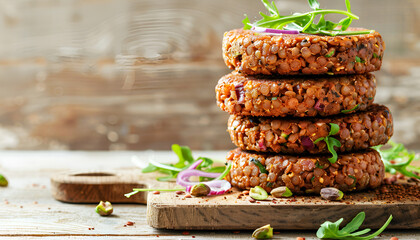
[228, 104, 393, 154]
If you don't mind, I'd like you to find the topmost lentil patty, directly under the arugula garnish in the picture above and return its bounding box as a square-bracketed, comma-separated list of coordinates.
[222, 28, 385, 75]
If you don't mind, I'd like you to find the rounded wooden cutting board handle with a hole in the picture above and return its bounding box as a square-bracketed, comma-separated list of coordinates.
[51, 171, 150, 204]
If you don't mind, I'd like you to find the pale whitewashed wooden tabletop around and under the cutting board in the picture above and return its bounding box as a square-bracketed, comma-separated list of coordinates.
[0, 151, 420, 240]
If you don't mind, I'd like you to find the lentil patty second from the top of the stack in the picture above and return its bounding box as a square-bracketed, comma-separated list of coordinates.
[216, 72, 376, 117]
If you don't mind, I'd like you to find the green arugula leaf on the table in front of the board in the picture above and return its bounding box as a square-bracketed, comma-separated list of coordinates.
[316, 212, 392, 240]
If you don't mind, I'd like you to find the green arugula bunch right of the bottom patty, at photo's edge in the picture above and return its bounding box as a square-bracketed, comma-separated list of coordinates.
[372, 141, 420, 179]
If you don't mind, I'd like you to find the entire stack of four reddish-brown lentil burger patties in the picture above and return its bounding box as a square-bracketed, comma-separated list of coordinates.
[216, 29, 393, 193]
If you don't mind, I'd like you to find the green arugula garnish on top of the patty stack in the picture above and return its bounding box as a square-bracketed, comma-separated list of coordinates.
[242, 0, 373, 36]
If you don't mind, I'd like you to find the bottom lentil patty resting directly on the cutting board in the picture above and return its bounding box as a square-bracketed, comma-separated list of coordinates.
[226, 148, 385, 193]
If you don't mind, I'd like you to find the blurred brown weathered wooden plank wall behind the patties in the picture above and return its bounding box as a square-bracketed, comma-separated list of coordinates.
[0, 0, 420, 150]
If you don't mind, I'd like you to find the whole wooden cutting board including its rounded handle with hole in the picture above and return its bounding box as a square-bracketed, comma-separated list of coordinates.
[51, 171, 420, 230]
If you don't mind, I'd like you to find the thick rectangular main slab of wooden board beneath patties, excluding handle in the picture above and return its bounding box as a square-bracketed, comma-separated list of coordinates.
[147, 187, 420, 230]
